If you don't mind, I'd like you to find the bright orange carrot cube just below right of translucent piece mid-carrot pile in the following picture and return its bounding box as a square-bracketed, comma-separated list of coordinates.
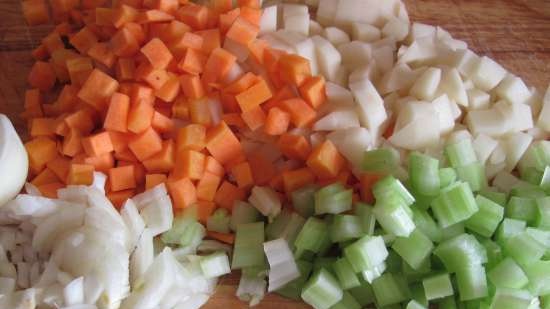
[206, 122, 242, 164]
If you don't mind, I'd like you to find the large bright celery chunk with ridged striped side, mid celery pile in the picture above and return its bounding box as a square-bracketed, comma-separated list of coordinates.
[432, 182, 478, 228]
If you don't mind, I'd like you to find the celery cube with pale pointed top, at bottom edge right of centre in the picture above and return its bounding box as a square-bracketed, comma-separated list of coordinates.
[301, 269, 344, 309]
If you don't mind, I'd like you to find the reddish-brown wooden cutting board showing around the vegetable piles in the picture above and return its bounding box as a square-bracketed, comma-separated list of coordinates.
[0, 0, 550, 309]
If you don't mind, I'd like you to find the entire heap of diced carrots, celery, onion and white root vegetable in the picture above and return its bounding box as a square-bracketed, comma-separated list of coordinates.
[4, 0, 550, 309]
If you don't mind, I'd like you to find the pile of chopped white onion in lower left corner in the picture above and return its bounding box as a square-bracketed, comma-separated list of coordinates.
[0, 173, 229, 309]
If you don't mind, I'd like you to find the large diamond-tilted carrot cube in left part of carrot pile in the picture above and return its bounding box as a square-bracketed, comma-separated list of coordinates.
[78, 69, 118, 110]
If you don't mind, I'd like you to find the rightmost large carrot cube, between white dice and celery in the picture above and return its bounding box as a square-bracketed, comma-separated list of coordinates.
[306, 140, 346, 179]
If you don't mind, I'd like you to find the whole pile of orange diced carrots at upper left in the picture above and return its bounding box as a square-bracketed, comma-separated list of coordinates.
[22, 0, 376, 242]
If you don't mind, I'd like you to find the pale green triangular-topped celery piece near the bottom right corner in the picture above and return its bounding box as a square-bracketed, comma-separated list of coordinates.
[487, 258, 529, 289]
